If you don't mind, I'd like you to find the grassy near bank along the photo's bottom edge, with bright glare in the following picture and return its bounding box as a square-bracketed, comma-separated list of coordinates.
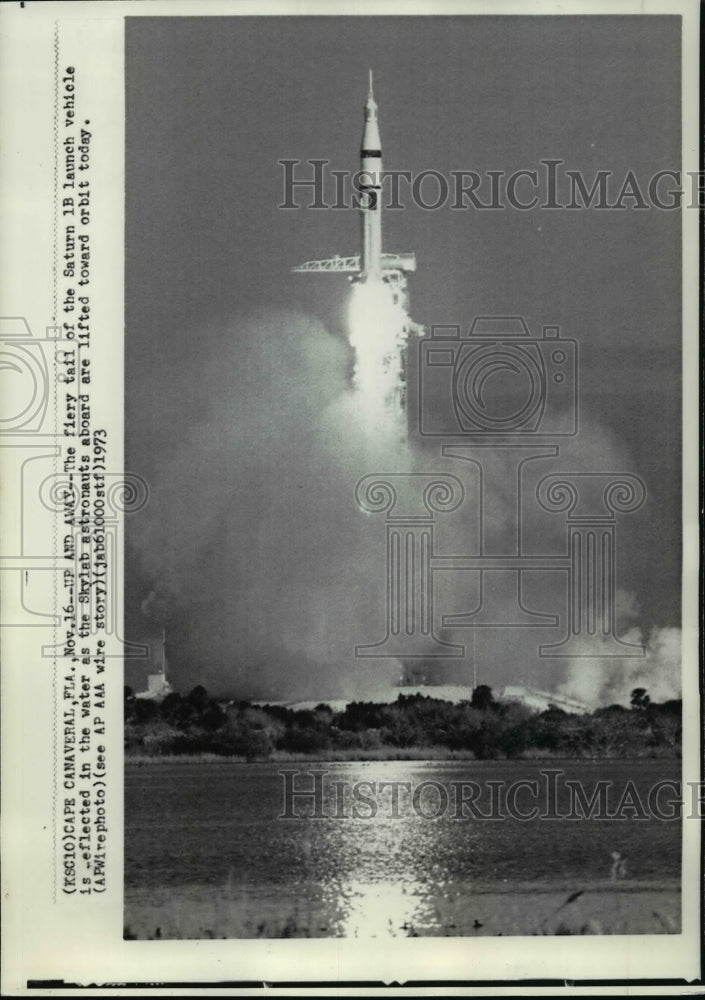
[125, 883, 680, 940]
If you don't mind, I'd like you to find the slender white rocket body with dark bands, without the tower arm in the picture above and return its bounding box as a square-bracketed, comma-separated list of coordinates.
[359, 70, 382, 281]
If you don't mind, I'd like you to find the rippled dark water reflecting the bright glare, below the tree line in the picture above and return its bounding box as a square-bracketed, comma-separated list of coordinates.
[125, 761, 681, 936]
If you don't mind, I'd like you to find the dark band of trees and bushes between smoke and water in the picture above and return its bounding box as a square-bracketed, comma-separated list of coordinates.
[125, 684, 681, 760]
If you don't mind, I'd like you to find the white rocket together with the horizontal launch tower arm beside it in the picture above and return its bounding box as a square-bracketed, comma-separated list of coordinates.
[292, 70, 416, 298]
